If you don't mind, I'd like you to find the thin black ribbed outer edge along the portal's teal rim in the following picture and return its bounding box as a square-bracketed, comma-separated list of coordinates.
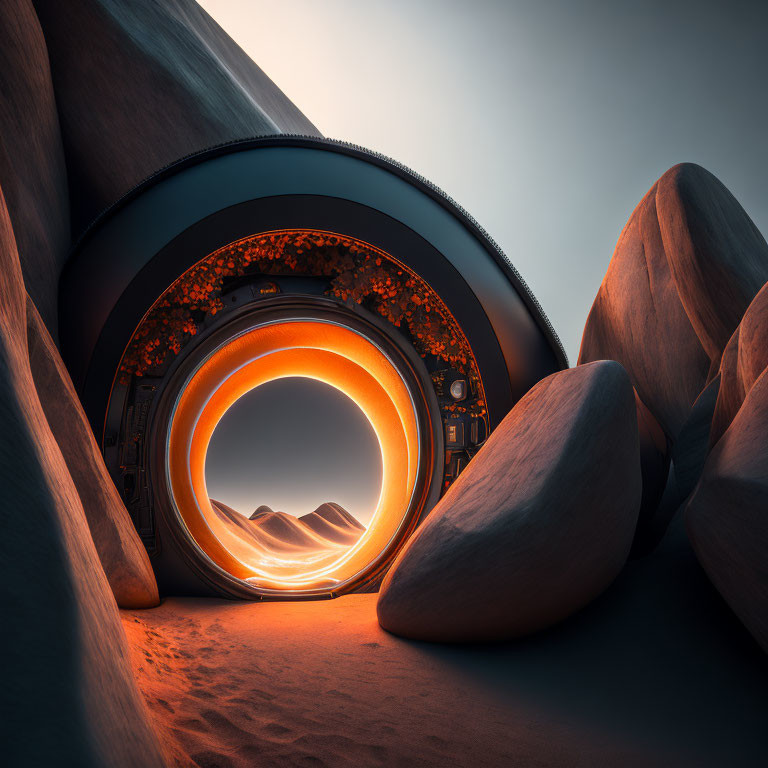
[70, 133, 569, 368]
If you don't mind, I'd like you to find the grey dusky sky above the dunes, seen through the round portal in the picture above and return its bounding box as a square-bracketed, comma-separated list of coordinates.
[205, 377, 381, 526]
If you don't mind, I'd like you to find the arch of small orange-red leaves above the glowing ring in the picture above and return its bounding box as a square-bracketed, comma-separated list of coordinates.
[120, 230, 480, 402]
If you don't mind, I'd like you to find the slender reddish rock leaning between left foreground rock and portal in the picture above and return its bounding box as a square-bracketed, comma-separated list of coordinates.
[27, 300, 160, 608]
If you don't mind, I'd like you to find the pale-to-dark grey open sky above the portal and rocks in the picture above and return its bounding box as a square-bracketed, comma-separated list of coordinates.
[201, 0, 768, 364]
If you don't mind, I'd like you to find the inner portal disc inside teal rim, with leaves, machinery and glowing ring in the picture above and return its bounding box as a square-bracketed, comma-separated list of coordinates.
[103, 224, 493, 599]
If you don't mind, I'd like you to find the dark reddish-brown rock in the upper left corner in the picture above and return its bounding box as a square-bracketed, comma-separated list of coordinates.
[0, 0, 70, 334]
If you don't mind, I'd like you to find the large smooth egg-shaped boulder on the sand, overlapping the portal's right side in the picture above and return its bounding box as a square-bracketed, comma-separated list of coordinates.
[378, 361, 641, 642]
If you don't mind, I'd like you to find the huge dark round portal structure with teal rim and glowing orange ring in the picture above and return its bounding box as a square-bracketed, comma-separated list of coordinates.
[60, 136, 567, 599]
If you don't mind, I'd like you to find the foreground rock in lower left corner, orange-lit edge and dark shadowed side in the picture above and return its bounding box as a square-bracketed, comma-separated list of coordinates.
[0, 189, 164, 768]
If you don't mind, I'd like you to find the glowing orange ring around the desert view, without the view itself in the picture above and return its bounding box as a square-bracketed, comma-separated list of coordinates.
[167, 320, 419, 592]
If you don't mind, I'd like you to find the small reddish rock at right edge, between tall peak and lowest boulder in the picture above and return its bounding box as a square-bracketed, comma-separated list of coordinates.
[710, 284, 768, 445]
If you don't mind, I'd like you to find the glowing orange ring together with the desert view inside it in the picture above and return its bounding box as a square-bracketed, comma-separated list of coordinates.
[165, 315, 431, 596]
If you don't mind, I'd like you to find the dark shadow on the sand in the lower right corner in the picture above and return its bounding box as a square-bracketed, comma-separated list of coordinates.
[402, 514, 768, 766]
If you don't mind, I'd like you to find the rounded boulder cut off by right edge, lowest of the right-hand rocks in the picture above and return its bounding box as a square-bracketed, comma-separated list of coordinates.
[686, 369, 768, 651]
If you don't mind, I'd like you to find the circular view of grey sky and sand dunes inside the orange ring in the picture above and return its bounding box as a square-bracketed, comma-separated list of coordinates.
[205, 377, 382, 569]
